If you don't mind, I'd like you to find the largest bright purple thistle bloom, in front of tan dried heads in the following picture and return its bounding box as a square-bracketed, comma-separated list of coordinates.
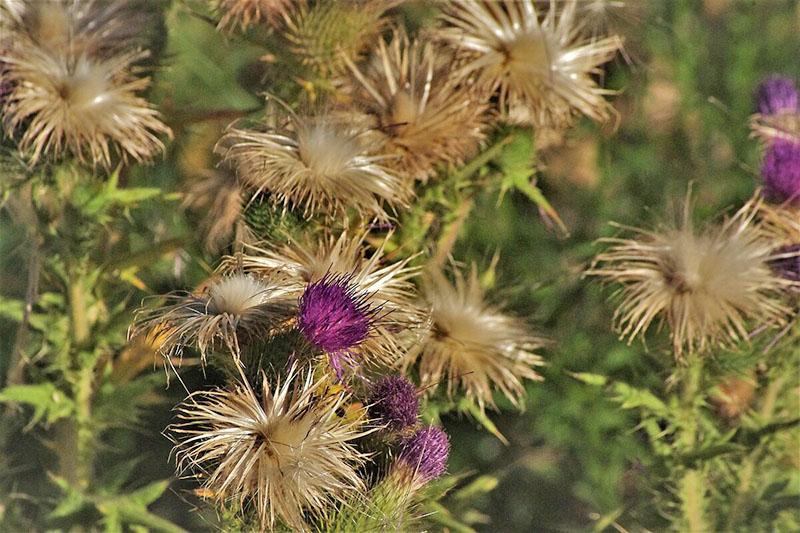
[298, 275, 376, 379]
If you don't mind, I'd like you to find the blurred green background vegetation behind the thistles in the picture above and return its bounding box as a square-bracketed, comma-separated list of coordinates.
[0, 0, 800, 531]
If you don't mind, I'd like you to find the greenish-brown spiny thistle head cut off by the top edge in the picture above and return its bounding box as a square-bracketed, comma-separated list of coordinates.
[284, 0, 403, 76]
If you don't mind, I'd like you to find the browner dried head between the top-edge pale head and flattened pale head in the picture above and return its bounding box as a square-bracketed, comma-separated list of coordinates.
[344, 30, 488, 181]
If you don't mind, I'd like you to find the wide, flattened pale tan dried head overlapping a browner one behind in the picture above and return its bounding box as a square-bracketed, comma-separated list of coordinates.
[219, 115, 411, 220]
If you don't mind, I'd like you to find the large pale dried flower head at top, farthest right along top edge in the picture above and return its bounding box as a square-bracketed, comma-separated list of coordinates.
[436, 0, 622, 127]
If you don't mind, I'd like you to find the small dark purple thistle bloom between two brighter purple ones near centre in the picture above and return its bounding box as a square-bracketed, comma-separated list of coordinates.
[369, 376, 419, 431]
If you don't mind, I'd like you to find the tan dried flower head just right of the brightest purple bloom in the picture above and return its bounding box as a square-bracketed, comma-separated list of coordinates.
[404, 268, 543, 409]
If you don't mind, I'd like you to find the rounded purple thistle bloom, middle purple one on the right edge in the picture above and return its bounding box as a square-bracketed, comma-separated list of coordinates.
[761, 139, 800, 204]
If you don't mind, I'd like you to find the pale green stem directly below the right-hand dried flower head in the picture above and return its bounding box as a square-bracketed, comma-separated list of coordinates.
[679, 354, 711, 533]
